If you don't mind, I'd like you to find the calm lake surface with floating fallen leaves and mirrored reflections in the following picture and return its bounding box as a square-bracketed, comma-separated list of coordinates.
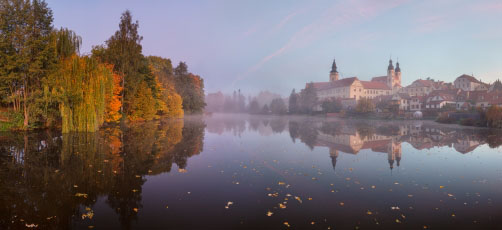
[0, 115, 502, 229]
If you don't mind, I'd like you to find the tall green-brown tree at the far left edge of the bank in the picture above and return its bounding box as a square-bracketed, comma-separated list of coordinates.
[0, 0, 55, 129]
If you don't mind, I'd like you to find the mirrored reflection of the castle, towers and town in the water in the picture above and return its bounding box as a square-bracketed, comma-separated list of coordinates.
[205, 115, 502, 170]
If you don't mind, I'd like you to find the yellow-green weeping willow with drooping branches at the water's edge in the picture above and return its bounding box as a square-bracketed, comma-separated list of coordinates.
[50, 55, 114, 133]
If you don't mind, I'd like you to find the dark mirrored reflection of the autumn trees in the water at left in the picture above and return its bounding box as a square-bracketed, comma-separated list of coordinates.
[0, 119, 205, 229]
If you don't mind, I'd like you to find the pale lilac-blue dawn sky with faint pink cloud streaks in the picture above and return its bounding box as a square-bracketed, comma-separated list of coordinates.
[47, 0, 502, 96]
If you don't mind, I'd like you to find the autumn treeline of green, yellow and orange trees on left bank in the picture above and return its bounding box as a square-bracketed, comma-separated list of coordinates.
[0, 0, 205, 132]
